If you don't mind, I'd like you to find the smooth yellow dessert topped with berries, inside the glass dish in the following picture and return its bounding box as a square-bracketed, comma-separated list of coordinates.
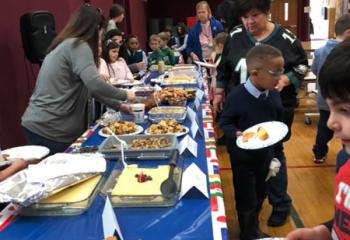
[112, 164, 169, 196]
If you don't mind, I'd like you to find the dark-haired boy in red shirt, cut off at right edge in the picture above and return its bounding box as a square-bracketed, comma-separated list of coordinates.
[286, 39, 350, 240]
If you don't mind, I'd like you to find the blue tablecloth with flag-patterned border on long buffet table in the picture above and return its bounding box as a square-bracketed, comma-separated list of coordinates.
[0, 68, 228, 240]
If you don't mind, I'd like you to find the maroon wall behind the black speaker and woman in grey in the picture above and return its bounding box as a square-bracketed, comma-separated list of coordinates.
[0, 0, 146, 149]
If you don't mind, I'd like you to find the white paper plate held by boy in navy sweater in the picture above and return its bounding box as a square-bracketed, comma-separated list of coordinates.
[236, 121, 288, 149]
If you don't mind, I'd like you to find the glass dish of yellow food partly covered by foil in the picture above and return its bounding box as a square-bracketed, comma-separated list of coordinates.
[20, 174, 106, 216]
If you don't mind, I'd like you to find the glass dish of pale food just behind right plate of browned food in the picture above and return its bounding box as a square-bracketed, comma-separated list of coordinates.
[148, 106, 186, 122]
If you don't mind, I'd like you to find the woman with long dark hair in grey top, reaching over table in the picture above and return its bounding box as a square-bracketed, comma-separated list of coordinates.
[22, 5, 135, 154]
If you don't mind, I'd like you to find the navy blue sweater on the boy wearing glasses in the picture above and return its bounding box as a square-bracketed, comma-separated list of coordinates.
[220, 85, 283, 160]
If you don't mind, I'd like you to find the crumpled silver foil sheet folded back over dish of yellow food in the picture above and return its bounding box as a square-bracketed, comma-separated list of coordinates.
[0, 153, 106, 206]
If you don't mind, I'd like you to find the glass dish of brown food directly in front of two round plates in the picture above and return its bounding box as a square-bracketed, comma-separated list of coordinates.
[99, 135, 177, 160]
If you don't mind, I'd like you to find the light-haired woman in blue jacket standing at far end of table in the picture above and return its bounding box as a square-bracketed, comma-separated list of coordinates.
[186, 1, 223, 61]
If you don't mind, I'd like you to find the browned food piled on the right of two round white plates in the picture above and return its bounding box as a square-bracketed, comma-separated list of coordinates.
[147, 119, 186, 134]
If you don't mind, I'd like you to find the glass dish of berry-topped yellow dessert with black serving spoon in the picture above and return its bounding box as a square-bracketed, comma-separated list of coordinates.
[102, 151, 183, 207]
